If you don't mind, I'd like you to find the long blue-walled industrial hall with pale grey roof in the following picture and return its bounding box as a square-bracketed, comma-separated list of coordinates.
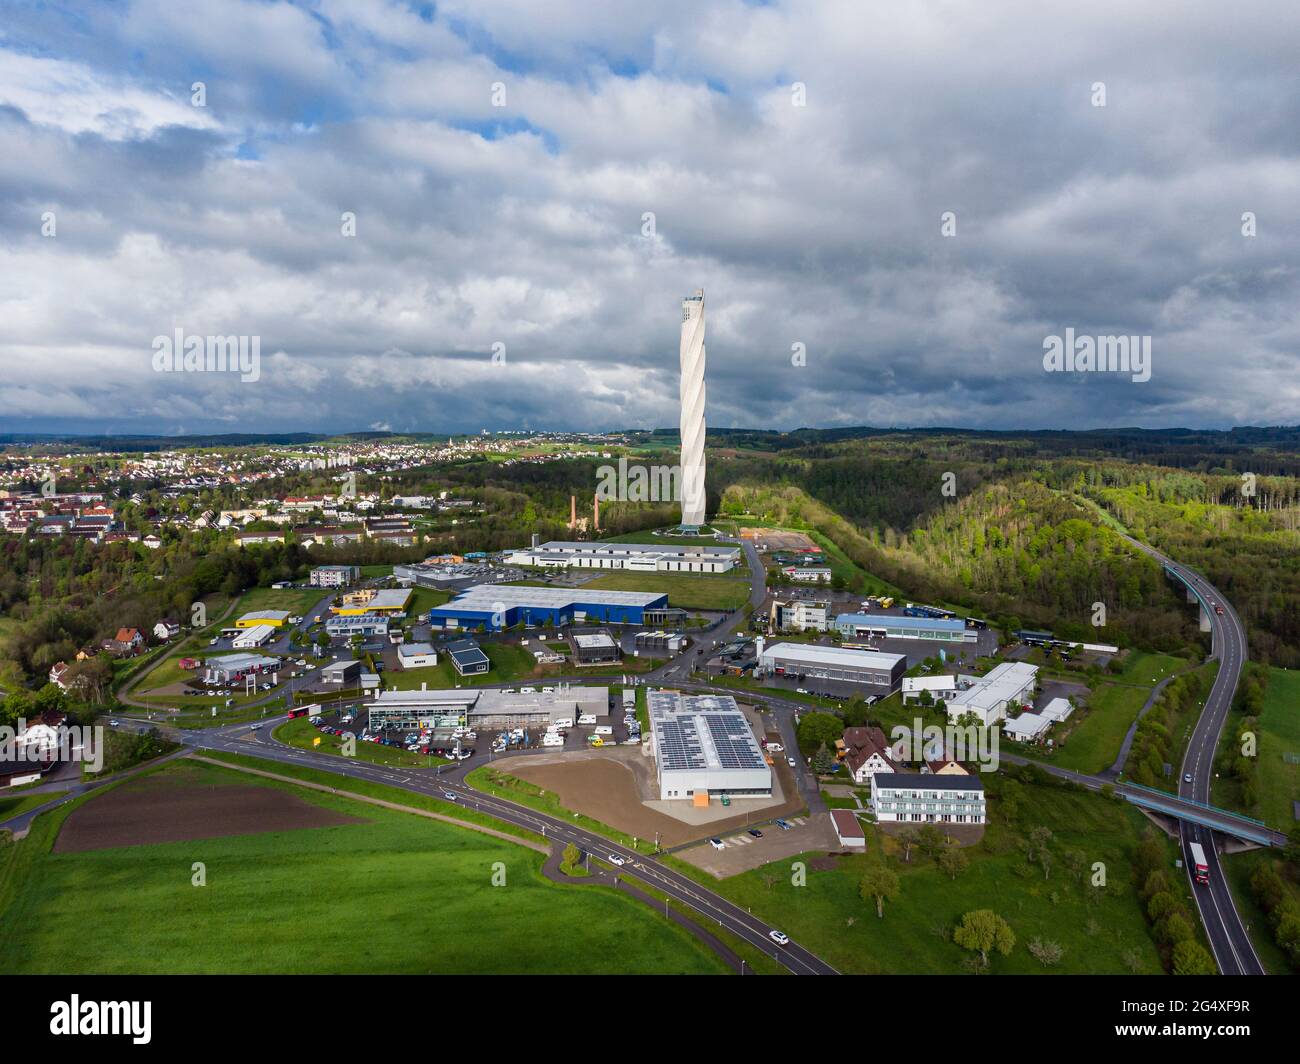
[429, 584, 668, 632]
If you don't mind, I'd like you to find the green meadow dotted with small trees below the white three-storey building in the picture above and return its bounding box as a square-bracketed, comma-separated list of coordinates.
[716, 775, 1174, 974]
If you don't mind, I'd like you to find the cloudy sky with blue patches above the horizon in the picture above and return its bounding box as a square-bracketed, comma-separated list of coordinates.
[0, 0, 1300, 433]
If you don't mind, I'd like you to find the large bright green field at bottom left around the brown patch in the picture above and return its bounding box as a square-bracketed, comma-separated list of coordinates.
[0, 762, 724, 974]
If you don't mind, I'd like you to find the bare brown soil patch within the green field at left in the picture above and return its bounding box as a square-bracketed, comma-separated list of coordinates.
[55, 778, 364, 853]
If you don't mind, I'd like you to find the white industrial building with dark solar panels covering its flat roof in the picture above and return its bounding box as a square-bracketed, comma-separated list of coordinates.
[646, 691, 772, 805]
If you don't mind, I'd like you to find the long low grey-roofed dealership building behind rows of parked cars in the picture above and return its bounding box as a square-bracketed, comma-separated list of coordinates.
[369, 685, 610, 730]
